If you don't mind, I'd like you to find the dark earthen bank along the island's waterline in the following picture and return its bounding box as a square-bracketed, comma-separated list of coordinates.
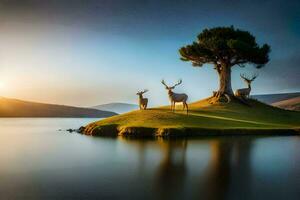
[79, 125, 300, 138]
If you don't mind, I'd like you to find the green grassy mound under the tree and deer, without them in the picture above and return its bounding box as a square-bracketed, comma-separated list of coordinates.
[84, 99, 300, 136]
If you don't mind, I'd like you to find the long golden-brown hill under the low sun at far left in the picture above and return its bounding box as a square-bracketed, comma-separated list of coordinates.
[0, 97, 116, 118]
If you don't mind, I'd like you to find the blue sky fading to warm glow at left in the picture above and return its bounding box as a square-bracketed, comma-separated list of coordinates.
[0, 0, 300, 106]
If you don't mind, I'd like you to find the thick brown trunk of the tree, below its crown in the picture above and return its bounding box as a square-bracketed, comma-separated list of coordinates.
[218, 66, 233, 96]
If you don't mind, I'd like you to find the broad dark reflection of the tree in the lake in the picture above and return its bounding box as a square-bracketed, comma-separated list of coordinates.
[197, 138, 252, 199]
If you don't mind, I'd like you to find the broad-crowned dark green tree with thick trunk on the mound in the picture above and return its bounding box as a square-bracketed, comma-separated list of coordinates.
[179, 26, 270, 101]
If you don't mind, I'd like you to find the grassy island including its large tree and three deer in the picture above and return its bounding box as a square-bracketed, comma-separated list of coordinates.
[81, 26, 300, 137]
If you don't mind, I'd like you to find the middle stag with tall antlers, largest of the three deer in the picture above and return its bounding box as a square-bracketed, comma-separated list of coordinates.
[161, 79, 189, 114]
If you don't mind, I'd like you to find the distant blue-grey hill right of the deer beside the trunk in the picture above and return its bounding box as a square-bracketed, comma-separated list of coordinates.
[252, 92, 300, 104]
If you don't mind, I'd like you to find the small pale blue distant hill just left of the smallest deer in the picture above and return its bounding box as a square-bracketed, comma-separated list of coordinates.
[92, 103, 138, 114]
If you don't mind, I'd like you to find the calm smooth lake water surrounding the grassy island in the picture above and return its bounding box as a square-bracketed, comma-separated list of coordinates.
[0, 119, 300, 200]
